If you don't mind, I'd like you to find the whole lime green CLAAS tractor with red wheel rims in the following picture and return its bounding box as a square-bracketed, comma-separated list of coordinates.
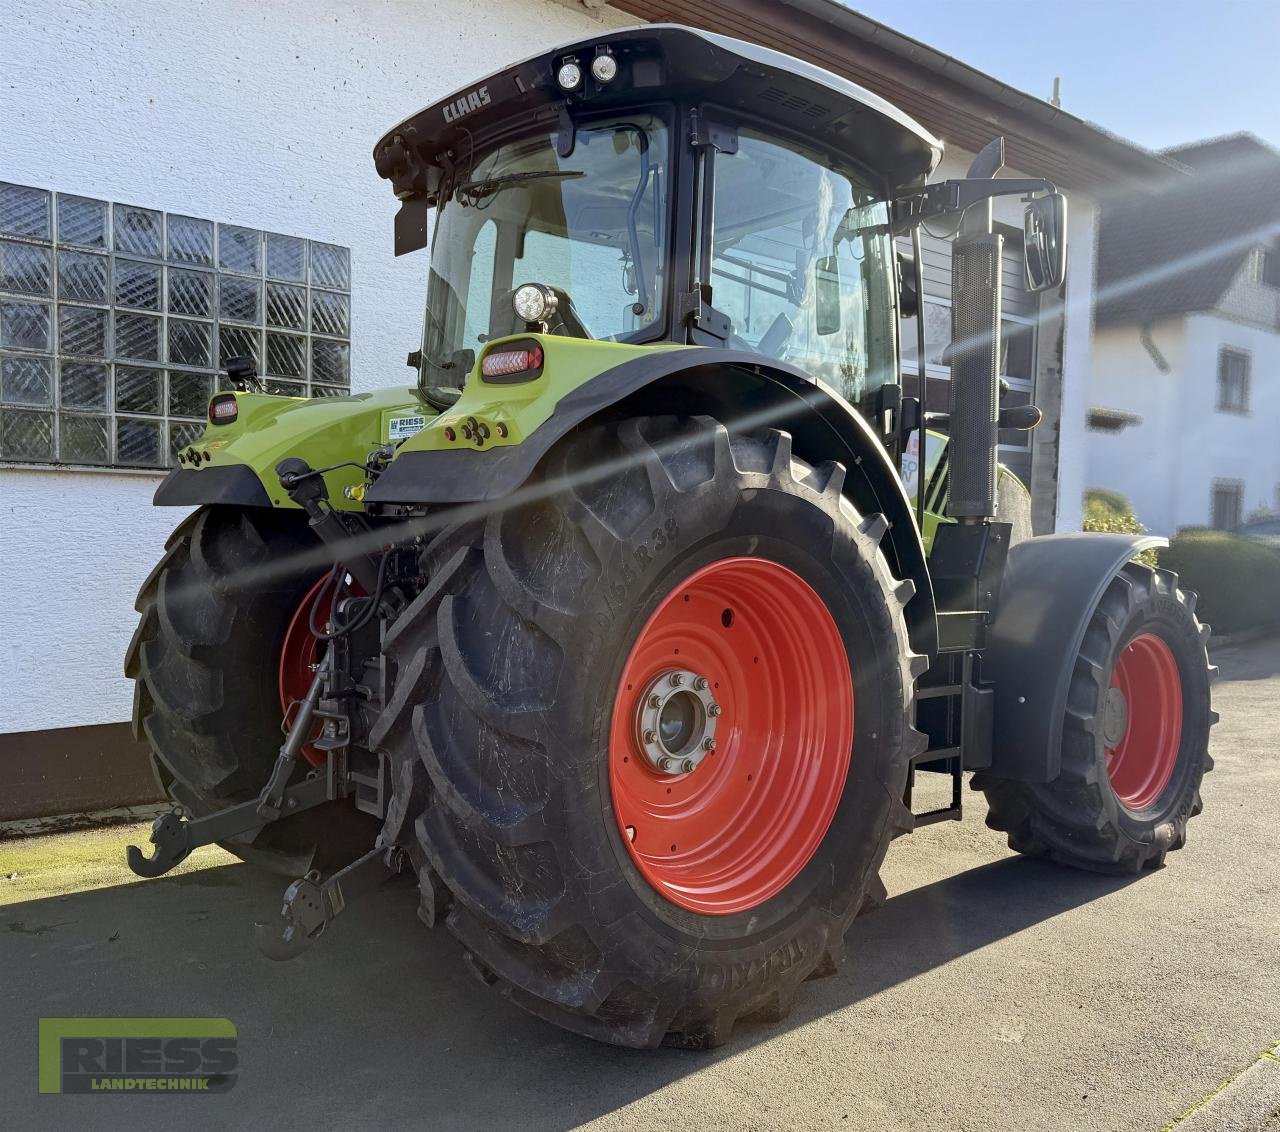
[127, 26, 1215, 1046]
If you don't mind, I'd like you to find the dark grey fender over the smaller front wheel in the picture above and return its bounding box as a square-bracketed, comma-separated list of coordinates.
[982, 534, 1169, 782]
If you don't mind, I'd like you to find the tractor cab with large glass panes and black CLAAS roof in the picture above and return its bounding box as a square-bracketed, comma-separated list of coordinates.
[375, 26, 941, 427]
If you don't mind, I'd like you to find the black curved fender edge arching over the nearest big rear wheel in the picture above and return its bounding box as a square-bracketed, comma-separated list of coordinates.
[366, 347, 937, 656]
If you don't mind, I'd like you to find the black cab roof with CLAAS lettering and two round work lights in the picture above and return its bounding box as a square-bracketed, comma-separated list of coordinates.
[374, 24, 942, 201]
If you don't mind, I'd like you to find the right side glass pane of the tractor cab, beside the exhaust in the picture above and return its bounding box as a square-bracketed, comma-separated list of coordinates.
[712, 129, 897, 412]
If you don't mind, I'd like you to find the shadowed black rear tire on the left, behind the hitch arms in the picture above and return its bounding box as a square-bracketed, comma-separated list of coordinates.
[124, 507, 378, 876]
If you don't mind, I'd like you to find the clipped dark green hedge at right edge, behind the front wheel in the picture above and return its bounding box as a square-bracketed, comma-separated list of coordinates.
[1160, 529, 1280, 634]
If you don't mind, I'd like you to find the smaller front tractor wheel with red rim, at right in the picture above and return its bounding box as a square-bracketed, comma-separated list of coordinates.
[973, 562, 1217, 873]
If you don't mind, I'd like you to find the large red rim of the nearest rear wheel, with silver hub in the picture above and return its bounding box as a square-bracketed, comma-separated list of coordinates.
[609, 557, 854, 916]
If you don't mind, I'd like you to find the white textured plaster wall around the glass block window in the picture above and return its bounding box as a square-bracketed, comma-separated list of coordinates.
[0, 0, 636, 732]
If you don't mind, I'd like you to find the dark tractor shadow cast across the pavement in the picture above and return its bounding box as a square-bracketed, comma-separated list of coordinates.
[0, 858, 1128, 1128]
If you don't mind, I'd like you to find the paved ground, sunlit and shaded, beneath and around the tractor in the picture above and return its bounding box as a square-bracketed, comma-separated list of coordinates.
[0, 638, 1280, 1132]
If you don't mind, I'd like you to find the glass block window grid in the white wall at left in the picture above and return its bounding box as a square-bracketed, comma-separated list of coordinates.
[0, 182, 351, 469]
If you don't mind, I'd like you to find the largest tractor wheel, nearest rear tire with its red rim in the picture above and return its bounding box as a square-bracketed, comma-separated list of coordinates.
[374, 417, 923, 1047]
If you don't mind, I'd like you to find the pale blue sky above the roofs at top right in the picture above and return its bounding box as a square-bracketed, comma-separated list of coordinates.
[844, 0, 1280, 150]
